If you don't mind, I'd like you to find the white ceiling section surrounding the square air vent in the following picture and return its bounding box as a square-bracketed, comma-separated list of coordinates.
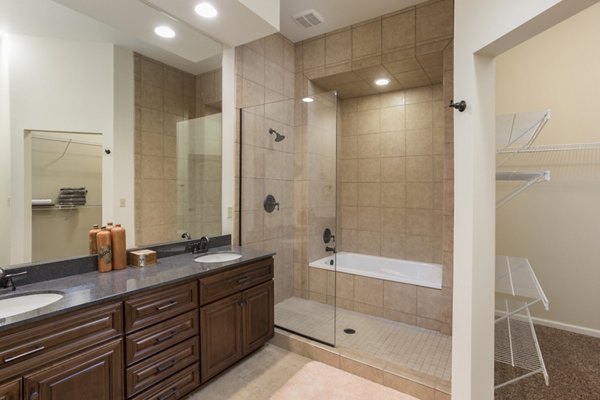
[281, 0, 425, 42]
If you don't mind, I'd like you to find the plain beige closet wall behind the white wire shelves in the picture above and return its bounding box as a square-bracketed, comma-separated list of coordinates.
[496, 4, 600, 335]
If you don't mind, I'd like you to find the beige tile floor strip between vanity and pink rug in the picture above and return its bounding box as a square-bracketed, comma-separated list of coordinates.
[187, 344, 311, 400]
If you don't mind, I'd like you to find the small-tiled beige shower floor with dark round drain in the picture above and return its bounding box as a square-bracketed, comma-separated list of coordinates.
[275, 297, 452, 381]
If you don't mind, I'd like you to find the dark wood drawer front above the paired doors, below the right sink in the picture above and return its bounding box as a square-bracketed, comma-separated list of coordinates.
[200, 258, 273, 305]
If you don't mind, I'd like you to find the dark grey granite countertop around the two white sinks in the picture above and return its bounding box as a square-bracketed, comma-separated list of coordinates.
[0, 246, 274, 332]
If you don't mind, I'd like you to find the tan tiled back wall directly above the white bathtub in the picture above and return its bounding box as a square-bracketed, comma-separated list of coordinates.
[338, 84, 446, 264]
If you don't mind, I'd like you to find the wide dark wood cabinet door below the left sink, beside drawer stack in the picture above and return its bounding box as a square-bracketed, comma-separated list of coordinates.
[24, 339, 123, 400]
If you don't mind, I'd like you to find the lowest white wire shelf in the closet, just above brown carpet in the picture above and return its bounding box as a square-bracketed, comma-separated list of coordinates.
[494, 300, 550, 389]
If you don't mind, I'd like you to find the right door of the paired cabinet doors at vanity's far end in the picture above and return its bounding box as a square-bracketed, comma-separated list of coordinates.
[242, 281, 274, 355]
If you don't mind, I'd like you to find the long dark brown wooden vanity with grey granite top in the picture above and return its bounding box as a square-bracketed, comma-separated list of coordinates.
[0, 249, 274, 400]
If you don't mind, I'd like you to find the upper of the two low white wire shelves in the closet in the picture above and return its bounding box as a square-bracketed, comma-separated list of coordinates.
[496, 256, 550, 321]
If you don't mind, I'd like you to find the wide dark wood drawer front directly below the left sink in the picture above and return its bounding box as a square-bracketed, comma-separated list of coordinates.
[0, 302, 123, 374]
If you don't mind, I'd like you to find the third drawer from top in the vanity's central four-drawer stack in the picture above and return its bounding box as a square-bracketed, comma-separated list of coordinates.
[127, 336, 200, 397]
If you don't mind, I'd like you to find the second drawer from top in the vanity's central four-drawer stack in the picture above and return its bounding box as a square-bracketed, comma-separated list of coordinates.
[125, 310, 198, 365]
